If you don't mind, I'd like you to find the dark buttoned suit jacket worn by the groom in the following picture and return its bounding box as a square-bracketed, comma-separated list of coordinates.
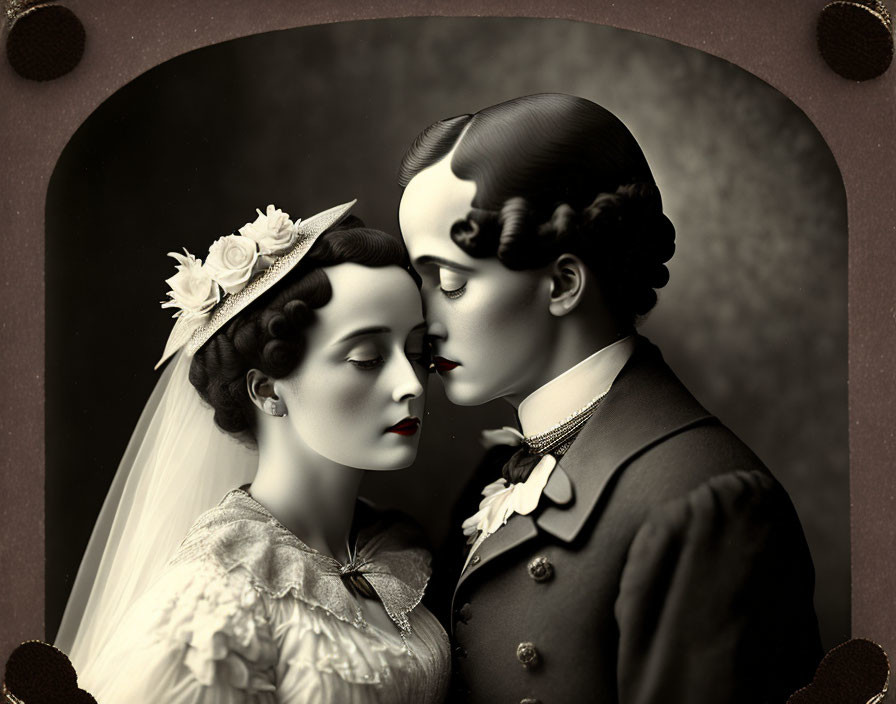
[450, 338, 822, 704]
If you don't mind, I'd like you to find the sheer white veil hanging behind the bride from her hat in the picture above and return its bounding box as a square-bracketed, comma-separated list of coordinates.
[55, 352, 258, 671]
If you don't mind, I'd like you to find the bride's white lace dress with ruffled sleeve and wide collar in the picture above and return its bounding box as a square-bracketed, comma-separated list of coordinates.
[79, 489, 450, 704]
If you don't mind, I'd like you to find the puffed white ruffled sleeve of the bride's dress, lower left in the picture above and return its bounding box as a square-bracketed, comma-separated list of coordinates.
[84, 532, 278, 702]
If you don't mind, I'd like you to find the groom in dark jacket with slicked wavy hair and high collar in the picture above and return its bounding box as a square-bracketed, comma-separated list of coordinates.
[399, 94, 821, 704]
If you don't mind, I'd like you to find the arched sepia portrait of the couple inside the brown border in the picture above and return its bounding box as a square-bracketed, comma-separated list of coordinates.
[3, 8, 890, 704]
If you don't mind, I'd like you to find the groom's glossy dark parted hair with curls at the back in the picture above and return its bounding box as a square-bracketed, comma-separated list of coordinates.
[399, 93, 675, 328]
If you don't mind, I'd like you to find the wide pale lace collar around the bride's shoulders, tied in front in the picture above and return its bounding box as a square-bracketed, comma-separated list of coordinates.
[171, 489, 431, 634]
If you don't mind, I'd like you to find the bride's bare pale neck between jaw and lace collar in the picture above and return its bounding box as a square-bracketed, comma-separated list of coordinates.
[249, 418, 364, 562]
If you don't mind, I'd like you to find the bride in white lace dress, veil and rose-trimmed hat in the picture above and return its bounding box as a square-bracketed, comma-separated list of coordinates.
[56, 204, 449, 704]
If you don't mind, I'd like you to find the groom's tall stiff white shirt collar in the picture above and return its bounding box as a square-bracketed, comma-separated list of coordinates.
[517, 335, 635, 436]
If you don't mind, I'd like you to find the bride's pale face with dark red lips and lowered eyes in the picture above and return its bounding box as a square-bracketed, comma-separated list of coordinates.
[274, 263, 428, 470]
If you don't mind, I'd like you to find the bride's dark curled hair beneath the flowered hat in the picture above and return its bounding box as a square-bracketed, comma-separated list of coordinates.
[190, 217, 409, 436]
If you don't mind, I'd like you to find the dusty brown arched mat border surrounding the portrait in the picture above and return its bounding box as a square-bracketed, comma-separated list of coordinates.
[0, 0, 896, 662]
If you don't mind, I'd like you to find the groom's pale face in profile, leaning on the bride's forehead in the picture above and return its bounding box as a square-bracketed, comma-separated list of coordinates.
[398, 154, 556, 406]
